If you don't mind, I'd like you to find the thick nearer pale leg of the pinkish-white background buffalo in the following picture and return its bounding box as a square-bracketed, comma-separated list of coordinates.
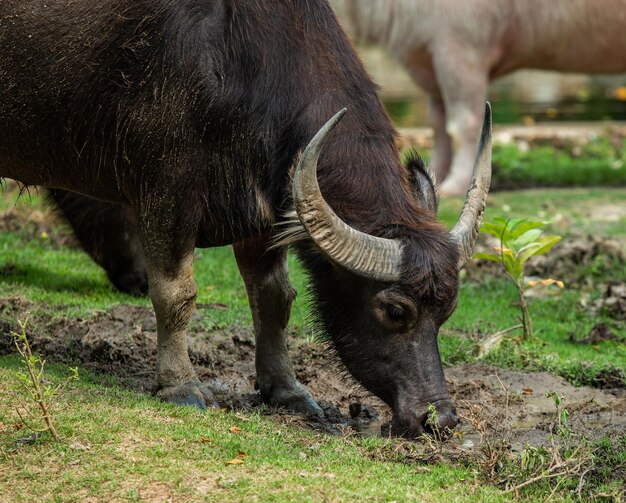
[433, 45, 488, 196]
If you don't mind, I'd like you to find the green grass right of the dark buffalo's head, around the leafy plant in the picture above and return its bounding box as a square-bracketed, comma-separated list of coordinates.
[440, 188, 626, 385]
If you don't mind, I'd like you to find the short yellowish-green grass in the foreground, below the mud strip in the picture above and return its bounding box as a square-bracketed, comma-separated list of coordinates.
[0, 357, 506, 502]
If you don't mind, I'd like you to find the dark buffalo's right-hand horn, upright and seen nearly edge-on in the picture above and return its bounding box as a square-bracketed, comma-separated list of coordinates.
[451, 102, 491, 269]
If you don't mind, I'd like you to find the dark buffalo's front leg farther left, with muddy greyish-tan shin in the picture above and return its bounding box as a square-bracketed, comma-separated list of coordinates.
[140, 210, 217, 409]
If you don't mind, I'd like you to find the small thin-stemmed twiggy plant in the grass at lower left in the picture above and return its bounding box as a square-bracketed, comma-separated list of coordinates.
[11, 318, 78, 442]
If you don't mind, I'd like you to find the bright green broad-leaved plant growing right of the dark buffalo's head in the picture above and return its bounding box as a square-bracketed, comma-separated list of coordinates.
[474, 217, 563, 339]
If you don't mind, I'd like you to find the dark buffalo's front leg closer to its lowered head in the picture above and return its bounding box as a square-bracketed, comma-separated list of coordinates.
[233, 235, 323, 416]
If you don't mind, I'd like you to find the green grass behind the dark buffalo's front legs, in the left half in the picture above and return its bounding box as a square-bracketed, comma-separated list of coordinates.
[0, 185, 310, 330]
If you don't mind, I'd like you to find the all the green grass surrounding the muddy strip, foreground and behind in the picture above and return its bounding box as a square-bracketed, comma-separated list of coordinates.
[0, 142, 626, 501]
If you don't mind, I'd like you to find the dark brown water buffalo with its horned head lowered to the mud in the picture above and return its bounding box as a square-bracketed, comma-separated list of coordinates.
[0, 0, 490, 435]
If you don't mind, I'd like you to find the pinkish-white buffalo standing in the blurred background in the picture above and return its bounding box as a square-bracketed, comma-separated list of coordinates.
[330, 0, 626, 195]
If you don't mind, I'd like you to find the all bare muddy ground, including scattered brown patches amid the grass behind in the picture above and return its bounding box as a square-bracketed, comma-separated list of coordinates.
[0, 178, 626, 456]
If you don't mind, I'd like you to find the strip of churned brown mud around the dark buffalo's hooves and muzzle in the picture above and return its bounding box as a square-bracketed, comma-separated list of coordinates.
[0, 298, 626, 449]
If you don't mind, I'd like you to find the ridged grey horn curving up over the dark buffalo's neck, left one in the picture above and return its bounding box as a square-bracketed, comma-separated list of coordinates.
[293, 108, 402, 281]
